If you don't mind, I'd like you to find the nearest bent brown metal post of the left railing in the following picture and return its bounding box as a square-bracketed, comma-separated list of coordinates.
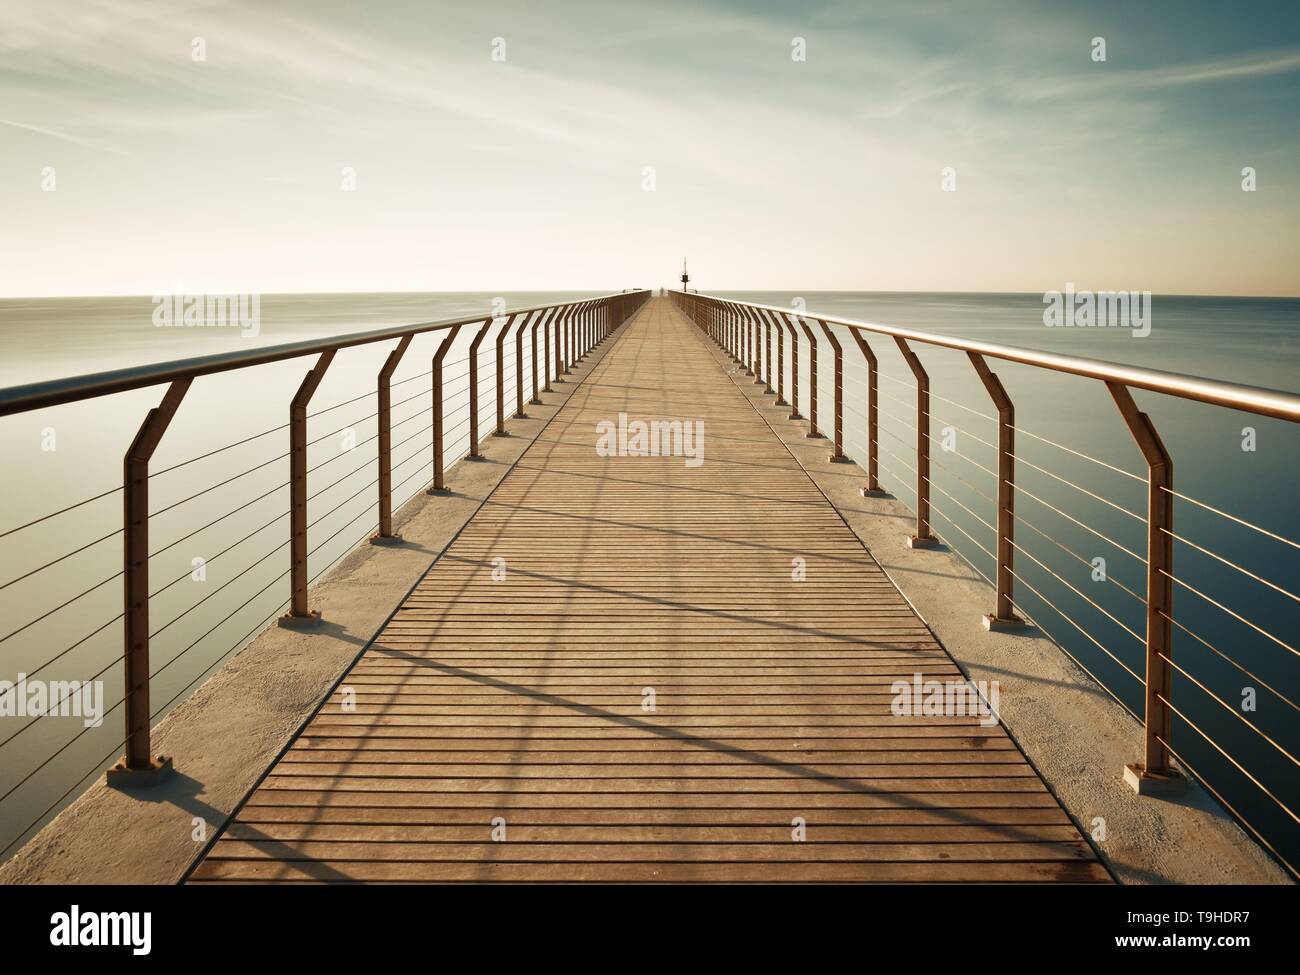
[108, 380, 191, 785]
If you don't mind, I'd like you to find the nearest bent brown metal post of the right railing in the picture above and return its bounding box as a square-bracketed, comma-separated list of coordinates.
[1106, 381, 1184, 796]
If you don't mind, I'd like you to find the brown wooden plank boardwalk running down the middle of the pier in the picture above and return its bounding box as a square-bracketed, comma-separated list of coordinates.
[191, 299, 1109, 883]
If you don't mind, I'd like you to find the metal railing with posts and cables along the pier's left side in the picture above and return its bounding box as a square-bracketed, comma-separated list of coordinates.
[0, 291, 649, 857]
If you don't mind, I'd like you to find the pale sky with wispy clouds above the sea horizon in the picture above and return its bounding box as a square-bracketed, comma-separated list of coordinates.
[0, 0, 1300, 296]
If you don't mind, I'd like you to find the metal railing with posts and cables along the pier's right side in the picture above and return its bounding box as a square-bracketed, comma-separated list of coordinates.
[670, 291, 1300, 876]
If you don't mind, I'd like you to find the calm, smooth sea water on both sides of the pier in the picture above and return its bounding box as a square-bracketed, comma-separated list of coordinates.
[0, 291, 1300, 878]
